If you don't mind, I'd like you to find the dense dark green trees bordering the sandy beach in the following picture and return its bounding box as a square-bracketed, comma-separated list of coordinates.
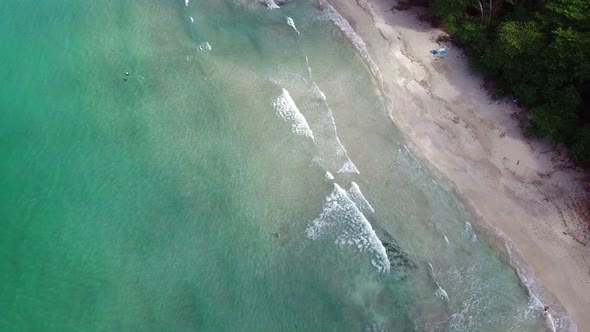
[430, 0, 590, 162]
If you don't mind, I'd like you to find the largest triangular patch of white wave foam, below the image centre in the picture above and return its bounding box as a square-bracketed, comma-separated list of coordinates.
[305, 183, 391, 273]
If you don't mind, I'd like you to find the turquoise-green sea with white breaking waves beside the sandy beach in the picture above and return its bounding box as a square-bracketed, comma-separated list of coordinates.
[0, 0, 544, 331]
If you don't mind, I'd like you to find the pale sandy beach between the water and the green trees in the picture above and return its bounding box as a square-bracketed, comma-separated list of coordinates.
[329, 0, 590, 331]
